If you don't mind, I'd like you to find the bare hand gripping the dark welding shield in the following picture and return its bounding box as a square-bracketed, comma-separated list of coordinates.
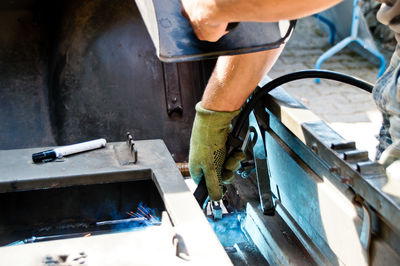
[181, 0, 228, 42]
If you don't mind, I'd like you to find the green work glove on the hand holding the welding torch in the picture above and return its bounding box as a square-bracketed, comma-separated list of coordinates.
[189, 102, 245, 201]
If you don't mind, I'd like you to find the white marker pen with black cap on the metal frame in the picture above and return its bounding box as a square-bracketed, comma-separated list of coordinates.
[32, 139, 107, 163]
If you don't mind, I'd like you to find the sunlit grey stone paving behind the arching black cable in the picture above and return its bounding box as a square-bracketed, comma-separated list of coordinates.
[269, 17, 390, 158]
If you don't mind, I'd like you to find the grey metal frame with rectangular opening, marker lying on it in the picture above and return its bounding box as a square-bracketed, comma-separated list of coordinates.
[0, 140, 231, 265]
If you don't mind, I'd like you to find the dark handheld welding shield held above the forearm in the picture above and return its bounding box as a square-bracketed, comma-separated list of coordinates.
[135, 0, 295, 62]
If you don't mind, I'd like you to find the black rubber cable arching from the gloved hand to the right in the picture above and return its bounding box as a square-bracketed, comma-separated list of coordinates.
[231, 70, 374, 142]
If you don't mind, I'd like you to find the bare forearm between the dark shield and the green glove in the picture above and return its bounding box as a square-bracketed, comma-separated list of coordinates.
[201, 45, 284, 111]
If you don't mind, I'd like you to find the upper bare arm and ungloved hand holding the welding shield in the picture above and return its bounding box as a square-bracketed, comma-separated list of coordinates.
[181, 0, 342, 41]
